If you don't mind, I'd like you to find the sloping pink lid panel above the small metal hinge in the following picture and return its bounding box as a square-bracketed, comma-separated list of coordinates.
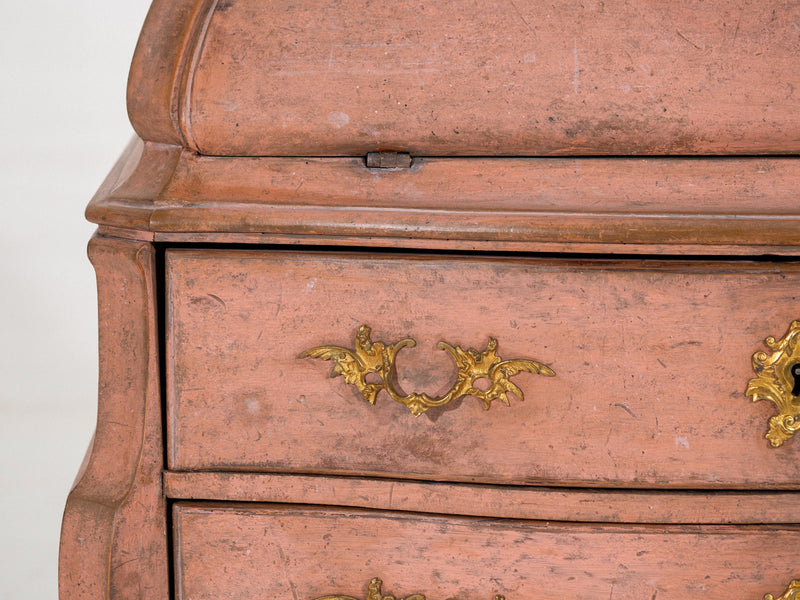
[164, 0, 800, 156]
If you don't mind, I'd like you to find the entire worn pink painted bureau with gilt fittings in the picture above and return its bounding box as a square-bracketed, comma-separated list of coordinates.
[60, 0, 800, 600]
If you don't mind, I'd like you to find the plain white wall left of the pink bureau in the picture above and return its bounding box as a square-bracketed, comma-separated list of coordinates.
[0, 0, 150, 600]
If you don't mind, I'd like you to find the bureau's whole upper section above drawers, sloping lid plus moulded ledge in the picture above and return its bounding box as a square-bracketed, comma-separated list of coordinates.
[88, 0, 800, 254]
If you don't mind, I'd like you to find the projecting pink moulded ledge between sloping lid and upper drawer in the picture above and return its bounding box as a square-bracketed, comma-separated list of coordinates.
[86, 138, 800, 256]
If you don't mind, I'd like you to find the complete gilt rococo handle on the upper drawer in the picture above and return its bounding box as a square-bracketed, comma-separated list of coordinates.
[300, 325, 555, 416]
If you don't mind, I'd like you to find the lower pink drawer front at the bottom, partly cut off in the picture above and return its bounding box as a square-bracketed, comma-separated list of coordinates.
[174, 503, 800, 600]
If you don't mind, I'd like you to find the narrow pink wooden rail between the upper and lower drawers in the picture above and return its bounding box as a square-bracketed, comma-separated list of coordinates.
[164, 471, 800, 525]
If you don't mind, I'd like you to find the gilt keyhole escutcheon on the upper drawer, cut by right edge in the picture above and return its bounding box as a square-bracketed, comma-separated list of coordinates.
[745, 321, 800, 448]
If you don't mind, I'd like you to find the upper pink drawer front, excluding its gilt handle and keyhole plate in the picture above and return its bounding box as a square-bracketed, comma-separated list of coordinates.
[166, 250, 800, 487]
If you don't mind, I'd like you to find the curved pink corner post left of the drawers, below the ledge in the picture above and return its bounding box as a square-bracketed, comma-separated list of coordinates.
[59, 237, 169, 600]
